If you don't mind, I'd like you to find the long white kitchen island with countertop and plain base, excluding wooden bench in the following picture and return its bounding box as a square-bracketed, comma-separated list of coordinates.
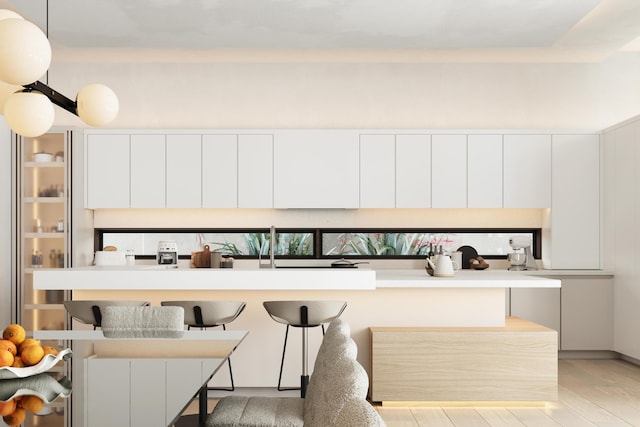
[34, 266, 560, 387]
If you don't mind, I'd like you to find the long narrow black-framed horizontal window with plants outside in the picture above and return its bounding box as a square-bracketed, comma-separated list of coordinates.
[96, 228, 541, 259]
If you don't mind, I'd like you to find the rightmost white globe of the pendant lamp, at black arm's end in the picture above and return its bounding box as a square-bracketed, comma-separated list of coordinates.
[76, 83, 120, 126]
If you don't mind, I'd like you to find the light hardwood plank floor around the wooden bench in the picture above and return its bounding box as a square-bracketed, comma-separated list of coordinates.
[187, 359, 640, 427]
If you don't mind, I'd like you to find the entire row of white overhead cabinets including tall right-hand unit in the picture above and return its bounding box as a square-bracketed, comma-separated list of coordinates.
[85, 130, 601, 269]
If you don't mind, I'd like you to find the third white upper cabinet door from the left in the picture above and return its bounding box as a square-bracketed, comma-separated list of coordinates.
[167, 134, 202, 208]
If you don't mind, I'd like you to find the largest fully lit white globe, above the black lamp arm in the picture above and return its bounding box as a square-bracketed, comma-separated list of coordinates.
[0, 18, 51, 85]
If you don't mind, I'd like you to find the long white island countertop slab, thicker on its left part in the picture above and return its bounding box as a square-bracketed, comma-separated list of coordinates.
[33, 266, 561, 290]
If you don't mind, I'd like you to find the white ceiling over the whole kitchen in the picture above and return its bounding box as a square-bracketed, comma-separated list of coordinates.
[0, 0, 640, 62]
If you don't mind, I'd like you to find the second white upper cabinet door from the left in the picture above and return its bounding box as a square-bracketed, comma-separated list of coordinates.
[130, 134, 167, 208]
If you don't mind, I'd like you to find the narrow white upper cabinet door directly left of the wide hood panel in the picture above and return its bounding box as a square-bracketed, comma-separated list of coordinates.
[238, 135, 272, 208]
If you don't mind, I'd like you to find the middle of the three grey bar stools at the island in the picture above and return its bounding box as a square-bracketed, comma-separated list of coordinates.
[160, 301, 247, 391]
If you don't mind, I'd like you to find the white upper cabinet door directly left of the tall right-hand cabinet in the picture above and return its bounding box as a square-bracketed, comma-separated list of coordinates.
[503, 135, 551, 208]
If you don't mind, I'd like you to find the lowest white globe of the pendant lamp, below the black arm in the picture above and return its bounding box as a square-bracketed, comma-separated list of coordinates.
[4, 92, 55, 138]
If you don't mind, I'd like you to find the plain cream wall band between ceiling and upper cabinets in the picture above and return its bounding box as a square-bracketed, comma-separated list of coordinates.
[49, 51, 640, 130]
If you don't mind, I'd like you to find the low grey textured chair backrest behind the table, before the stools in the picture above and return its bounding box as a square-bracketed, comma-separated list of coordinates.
[102, 306, 184, 338]
